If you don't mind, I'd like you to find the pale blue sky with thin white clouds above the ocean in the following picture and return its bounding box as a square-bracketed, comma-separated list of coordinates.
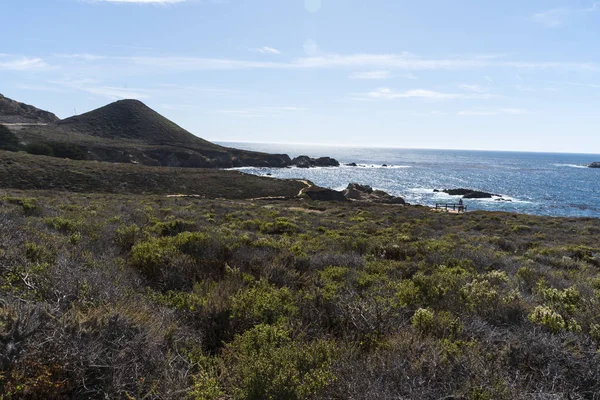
[0, 0, 600, 153]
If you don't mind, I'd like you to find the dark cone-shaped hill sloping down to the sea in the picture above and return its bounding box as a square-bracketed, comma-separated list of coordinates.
[11, 100, 291, 168]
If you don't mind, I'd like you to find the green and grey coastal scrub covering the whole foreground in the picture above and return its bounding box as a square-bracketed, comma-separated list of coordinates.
[0, 189, 600, 400]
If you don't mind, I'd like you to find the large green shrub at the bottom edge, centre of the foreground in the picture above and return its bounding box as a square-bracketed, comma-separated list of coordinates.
[224, 325, 338, 400]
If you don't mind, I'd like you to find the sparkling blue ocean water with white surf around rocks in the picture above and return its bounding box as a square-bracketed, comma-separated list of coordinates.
[221, 142, 600, 218]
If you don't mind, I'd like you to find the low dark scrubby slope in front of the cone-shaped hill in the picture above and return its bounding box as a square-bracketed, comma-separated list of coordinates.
[0, 151, 306, 199]
